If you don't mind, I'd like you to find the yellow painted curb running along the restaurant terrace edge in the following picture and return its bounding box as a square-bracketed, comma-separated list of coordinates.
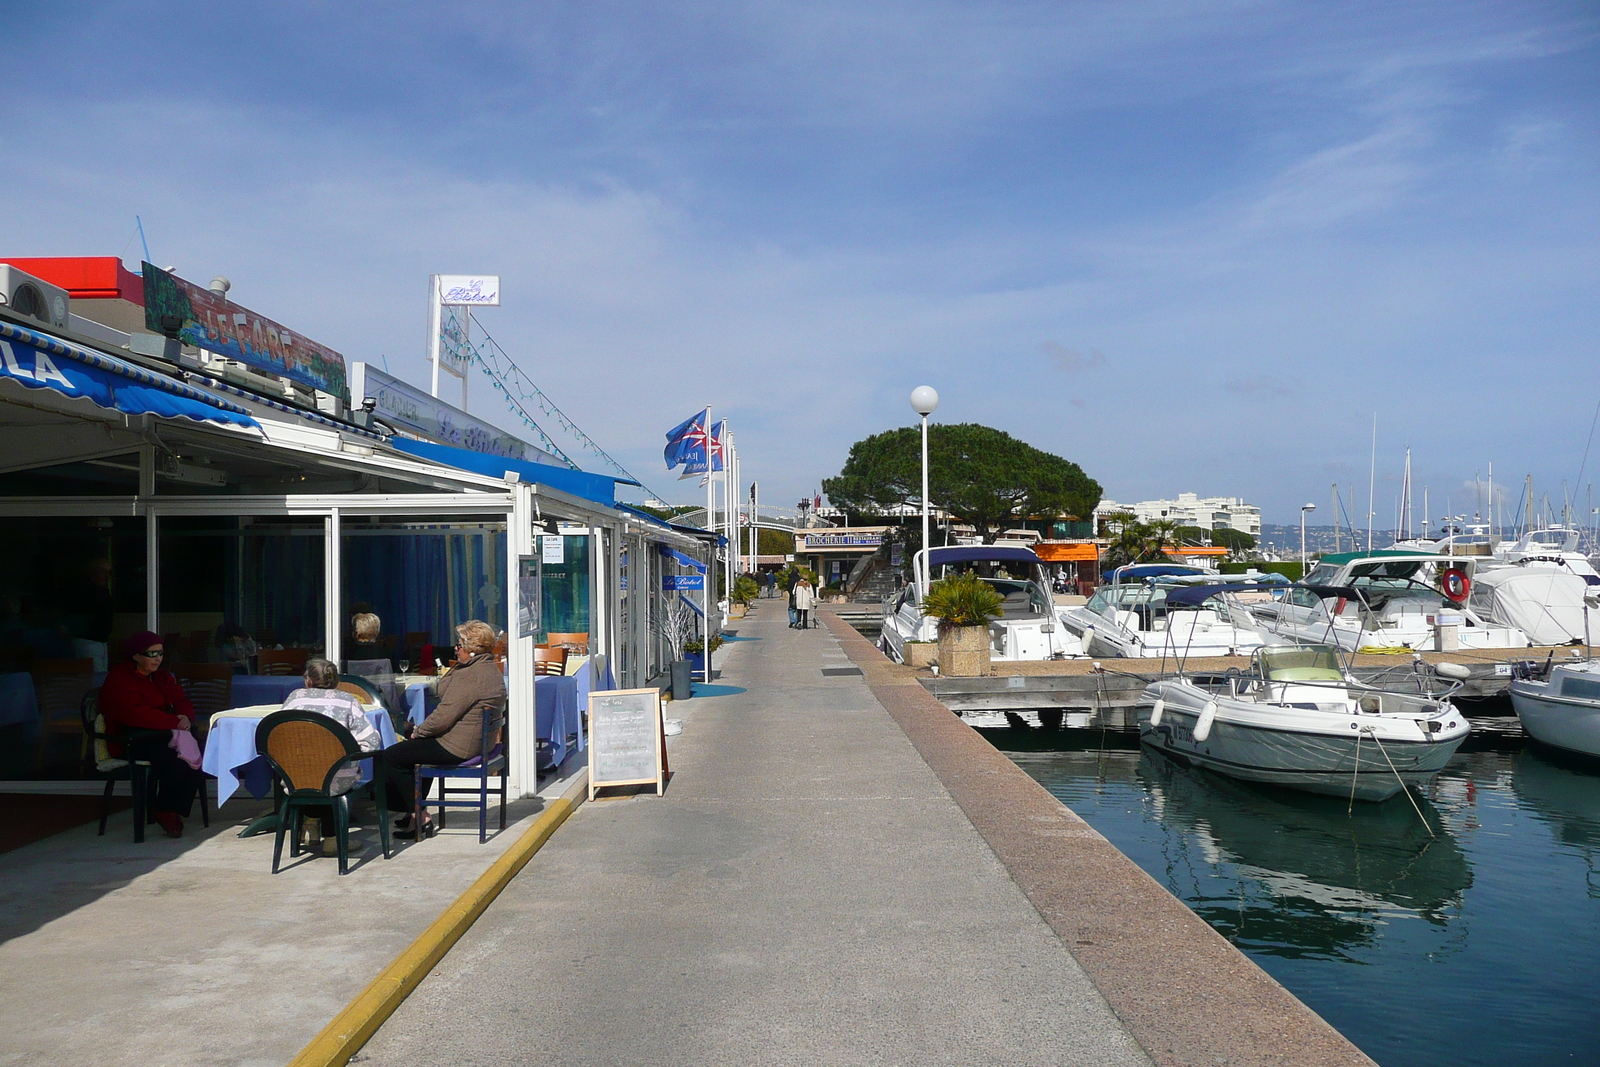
[288, 769, 589, 1067]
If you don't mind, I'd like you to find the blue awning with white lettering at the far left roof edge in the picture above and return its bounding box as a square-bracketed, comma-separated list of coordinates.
[0, 322, 261, 429]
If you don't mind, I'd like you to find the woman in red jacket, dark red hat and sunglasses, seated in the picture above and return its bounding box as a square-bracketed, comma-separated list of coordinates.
[99, 630, 203, 837]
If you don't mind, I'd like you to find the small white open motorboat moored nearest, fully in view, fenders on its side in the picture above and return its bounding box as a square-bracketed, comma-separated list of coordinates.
[1136, 645, 1470, 800]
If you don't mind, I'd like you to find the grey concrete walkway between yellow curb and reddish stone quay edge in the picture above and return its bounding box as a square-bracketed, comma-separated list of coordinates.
[352, 600, 1152, 1067]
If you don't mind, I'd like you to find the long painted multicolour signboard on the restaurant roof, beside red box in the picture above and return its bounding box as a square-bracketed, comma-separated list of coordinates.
[144, 264, 350, 402]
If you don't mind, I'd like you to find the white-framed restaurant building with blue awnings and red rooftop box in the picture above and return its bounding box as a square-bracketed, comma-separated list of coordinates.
[0, 258, 717, 792]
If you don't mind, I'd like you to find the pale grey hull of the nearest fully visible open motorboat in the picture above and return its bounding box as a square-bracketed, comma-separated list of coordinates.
[1138, 704, 1467, 800]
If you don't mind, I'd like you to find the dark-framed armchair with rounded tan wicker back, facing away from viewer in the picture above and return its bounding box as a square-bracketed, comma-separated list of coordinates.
[256, 712, 392, 875]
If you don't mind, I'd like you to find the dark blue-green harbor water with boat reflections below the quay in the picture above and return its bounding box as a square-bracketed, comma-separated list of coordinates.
[974, 718, 1600, 1067]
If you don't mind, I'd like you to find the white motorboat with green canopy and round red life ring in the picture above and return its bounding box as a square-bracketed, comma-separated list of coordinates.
[1250, 549, 1530, 653]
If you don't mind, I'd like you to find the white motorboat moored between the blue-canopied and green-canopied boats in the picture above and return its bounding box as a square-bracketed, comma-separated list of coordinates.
[1059, 576, 1266, 659]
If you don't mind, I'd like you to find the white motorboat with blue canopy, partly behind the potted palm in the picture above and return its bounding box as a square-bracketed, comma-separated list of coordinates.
[878, 544, 1083, 662]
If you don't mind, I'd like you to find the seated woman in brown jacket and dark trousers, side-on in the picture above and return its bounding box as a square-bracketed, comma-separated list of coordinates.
[384, 619, 506, 838]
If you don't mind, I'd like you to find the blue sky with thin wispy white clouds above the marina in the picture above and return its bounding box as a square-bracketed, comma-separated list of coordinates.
[0, 0, 1600, 526]
